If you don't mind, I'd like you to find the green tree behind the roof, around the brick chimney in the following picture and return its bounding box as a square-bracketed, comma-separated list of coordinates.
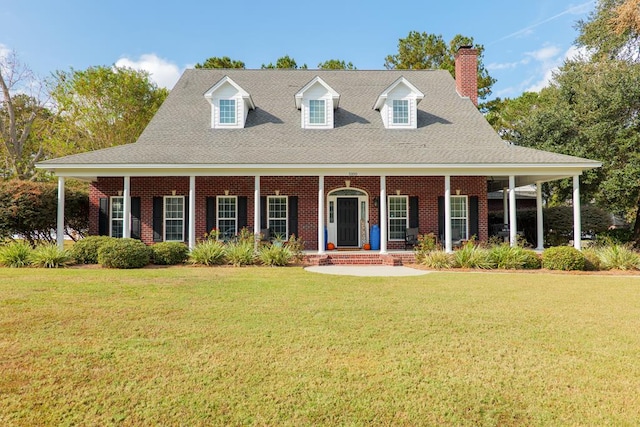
[384, 31, 496, 99]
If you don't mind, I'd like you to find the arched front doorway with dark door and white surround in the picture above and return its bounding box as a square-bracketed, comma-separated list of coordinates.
[327, 188, 369, 248]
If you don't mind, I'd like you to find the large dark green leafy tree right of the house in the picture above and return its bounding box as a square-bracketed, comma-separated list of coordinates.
[514, 59, 640, 243]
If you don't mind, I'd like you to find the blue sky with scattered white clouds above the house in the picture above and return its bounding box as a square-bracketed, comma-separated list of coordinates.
[0, 0, 596, 98]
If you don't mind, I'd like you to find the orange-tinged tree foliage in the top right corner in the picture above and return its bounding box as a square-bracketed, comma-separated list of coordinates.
[576, 0, 640, 62]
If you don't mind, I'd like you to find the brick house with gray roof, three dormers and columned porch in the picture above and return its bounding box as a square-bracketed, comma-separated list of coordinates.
[38, 48, 600, 253]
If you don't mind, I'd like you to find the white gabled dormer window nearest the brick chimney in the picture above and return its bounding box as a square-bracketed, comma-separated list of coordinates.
[373, 77, 424, 129]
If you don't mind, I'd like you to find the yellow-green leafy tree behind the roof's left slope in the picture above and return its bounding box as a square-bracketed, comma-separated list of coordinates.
[52, 66, 168, 154]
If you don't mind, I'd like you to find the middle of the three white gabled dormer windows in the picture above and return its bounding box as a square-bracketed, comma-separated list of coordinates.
[295, 77, 340, 129]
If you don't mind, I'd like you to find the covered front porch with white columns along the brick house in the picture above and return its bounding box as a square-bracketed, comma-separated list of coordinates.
[52, 168, 592, 262]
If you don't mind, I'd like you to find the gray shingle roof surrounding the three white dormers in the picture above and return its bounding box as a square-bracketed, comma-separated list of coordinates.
[41, 70, 597, 168]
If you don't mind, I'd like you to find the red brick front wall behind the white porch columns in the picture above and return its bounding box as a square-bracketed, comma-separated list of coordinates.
[89, 176, 488, 250]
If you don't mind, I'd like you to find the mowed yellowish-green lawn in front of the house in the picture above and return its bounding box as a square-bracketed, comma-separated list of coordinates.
[0, 267, 640, 426]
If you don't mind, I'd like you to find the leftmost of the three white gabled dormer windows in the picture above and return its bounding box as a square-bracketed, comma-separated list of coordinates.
[204, 76, 255, 129]
